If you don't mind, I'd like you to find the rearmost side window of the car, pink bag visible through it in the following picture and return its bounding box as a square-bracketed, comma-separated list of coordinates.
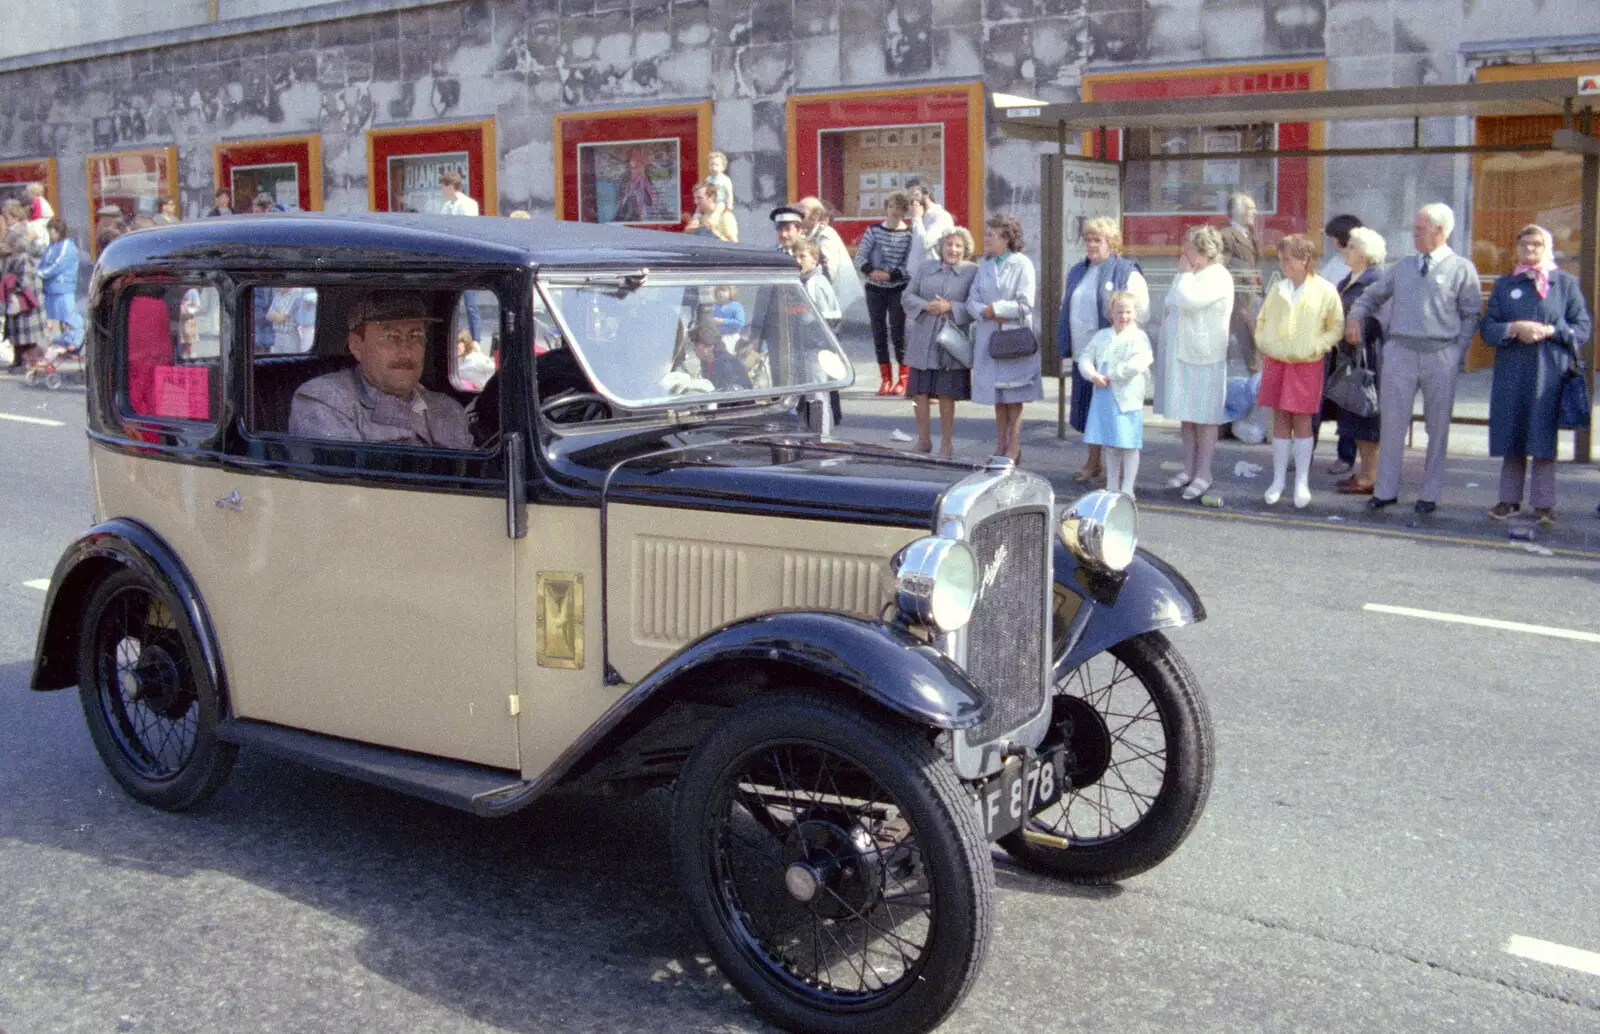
[122, 285, 222, 421]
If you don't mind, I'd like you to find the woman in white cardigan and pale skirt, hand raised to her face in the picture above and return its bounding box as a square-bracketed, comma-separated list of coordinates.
[1155, 226, 1235, 499]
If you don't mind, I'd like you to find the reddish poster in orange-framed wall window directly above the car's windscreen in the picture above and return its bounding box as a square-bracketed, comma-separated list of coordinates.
[578, 136, 683, 226]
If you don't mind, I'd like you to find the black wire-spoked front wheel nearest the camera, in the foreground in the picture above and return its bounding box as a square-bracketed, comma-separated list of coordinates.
[672, 693, 994, 1034]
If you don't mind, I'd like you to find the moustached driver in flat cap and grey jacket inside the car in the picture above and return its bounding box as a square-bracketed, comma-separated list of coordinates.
[288, 291, 472, 448]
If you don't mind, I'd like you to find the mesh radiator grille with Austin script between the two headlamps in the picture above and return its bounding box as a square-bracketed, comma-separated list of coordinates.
[966, 511, 1050, 744]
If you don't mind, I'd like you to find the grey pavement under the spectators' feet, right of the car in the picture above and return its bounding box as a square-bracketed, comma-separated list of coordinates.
[837, 328, 1600, 554]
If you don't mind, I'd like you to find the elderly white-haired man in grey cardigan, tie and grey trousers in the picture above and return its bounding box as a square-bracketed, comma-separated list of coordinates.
[1344, 203, 1483, 514]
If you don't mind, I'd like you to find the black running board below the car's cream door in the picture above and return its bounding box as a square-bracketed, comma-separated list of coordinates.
[216, 719, 538, 818]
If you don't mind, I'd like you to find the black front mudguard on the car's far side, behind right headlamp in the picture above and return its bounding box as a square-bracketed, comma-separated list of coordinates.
[1053, 541, 1205, 680]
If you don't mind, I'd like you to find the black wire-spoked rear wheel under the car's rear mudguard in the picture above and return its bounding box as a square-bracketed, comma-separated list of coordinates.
[78, 570, 238, 812]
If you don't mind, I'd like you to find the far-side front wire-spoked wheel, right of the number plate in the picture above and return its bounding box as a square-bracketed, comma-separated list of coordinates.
[1000, 632, 1214, 884]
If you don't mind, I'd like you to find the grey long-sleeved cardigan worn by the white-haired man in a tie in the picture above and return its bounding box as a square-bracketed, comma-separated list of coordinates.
[1347, 251, 1483, 352]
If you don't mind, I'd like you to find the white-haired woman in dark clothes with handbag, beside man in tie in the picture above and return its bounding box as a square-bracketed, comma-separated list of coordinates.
[1312, 226, 1389, 496]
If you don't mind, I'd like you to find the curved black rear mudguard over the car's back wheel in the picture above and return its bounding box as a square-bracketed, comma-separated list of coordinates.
[30, 517, 222, 690]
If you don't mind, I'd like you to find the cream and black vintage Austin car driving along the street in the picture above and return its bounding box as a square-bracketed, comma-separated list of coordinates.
[32, 214, 1213, 1032]
